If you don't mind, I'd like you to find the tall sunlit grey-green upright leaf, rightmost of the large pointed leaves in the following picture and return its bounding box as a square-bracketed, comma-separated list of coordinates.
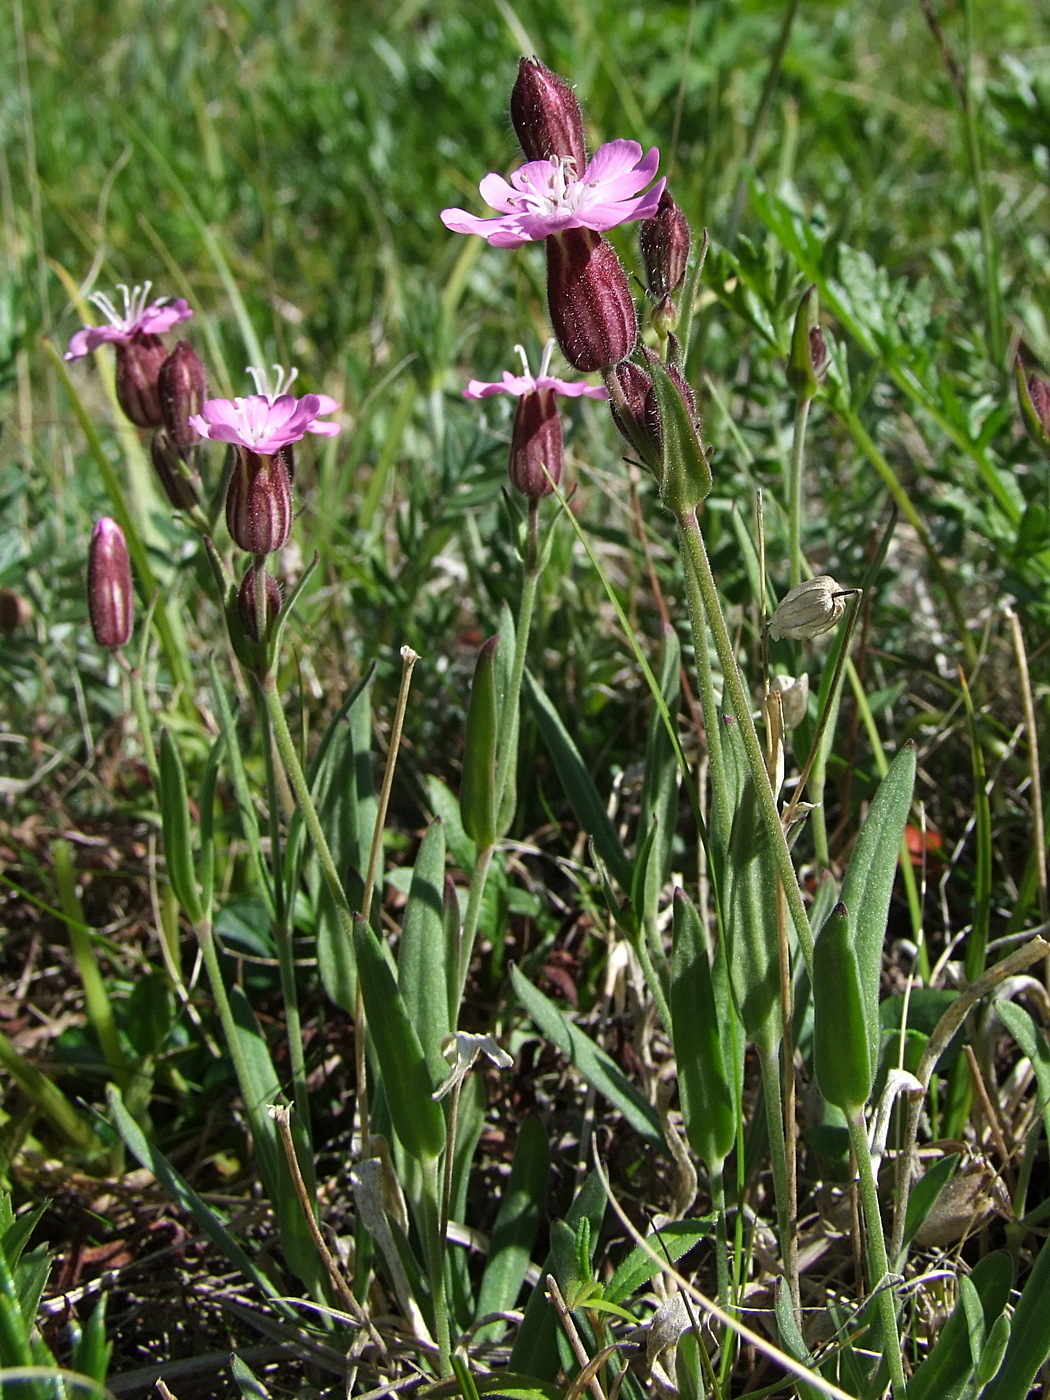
[839, 742, 916, 1064]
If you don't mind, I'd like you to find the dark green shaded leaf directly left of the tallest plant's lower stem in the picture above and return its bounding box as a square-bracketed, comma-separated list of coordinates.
[669, 889, 736, 1168]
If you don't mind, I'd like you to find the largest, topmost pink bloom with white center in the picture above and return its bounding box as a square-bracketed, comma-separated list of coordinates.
[441, 140, 666, 248]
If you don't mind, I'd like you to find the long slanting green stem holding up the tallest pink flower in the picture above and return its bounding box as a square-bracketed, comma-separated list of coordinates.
[678, 512, 813, 967]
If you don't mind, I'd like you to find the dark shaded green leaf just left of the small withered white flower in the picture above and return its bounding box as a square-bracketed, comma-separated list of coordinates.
[354, 917, 445, 1163]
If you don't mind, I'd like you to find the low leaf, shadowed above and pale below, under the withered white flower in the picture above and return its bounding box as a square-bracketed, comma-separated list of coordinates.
[475, 1114, 550, 1341]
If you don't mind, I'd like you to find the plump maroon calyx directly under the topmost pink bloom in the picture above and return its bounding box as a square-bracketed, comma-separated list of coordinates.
[546, 228, 638, 374]
